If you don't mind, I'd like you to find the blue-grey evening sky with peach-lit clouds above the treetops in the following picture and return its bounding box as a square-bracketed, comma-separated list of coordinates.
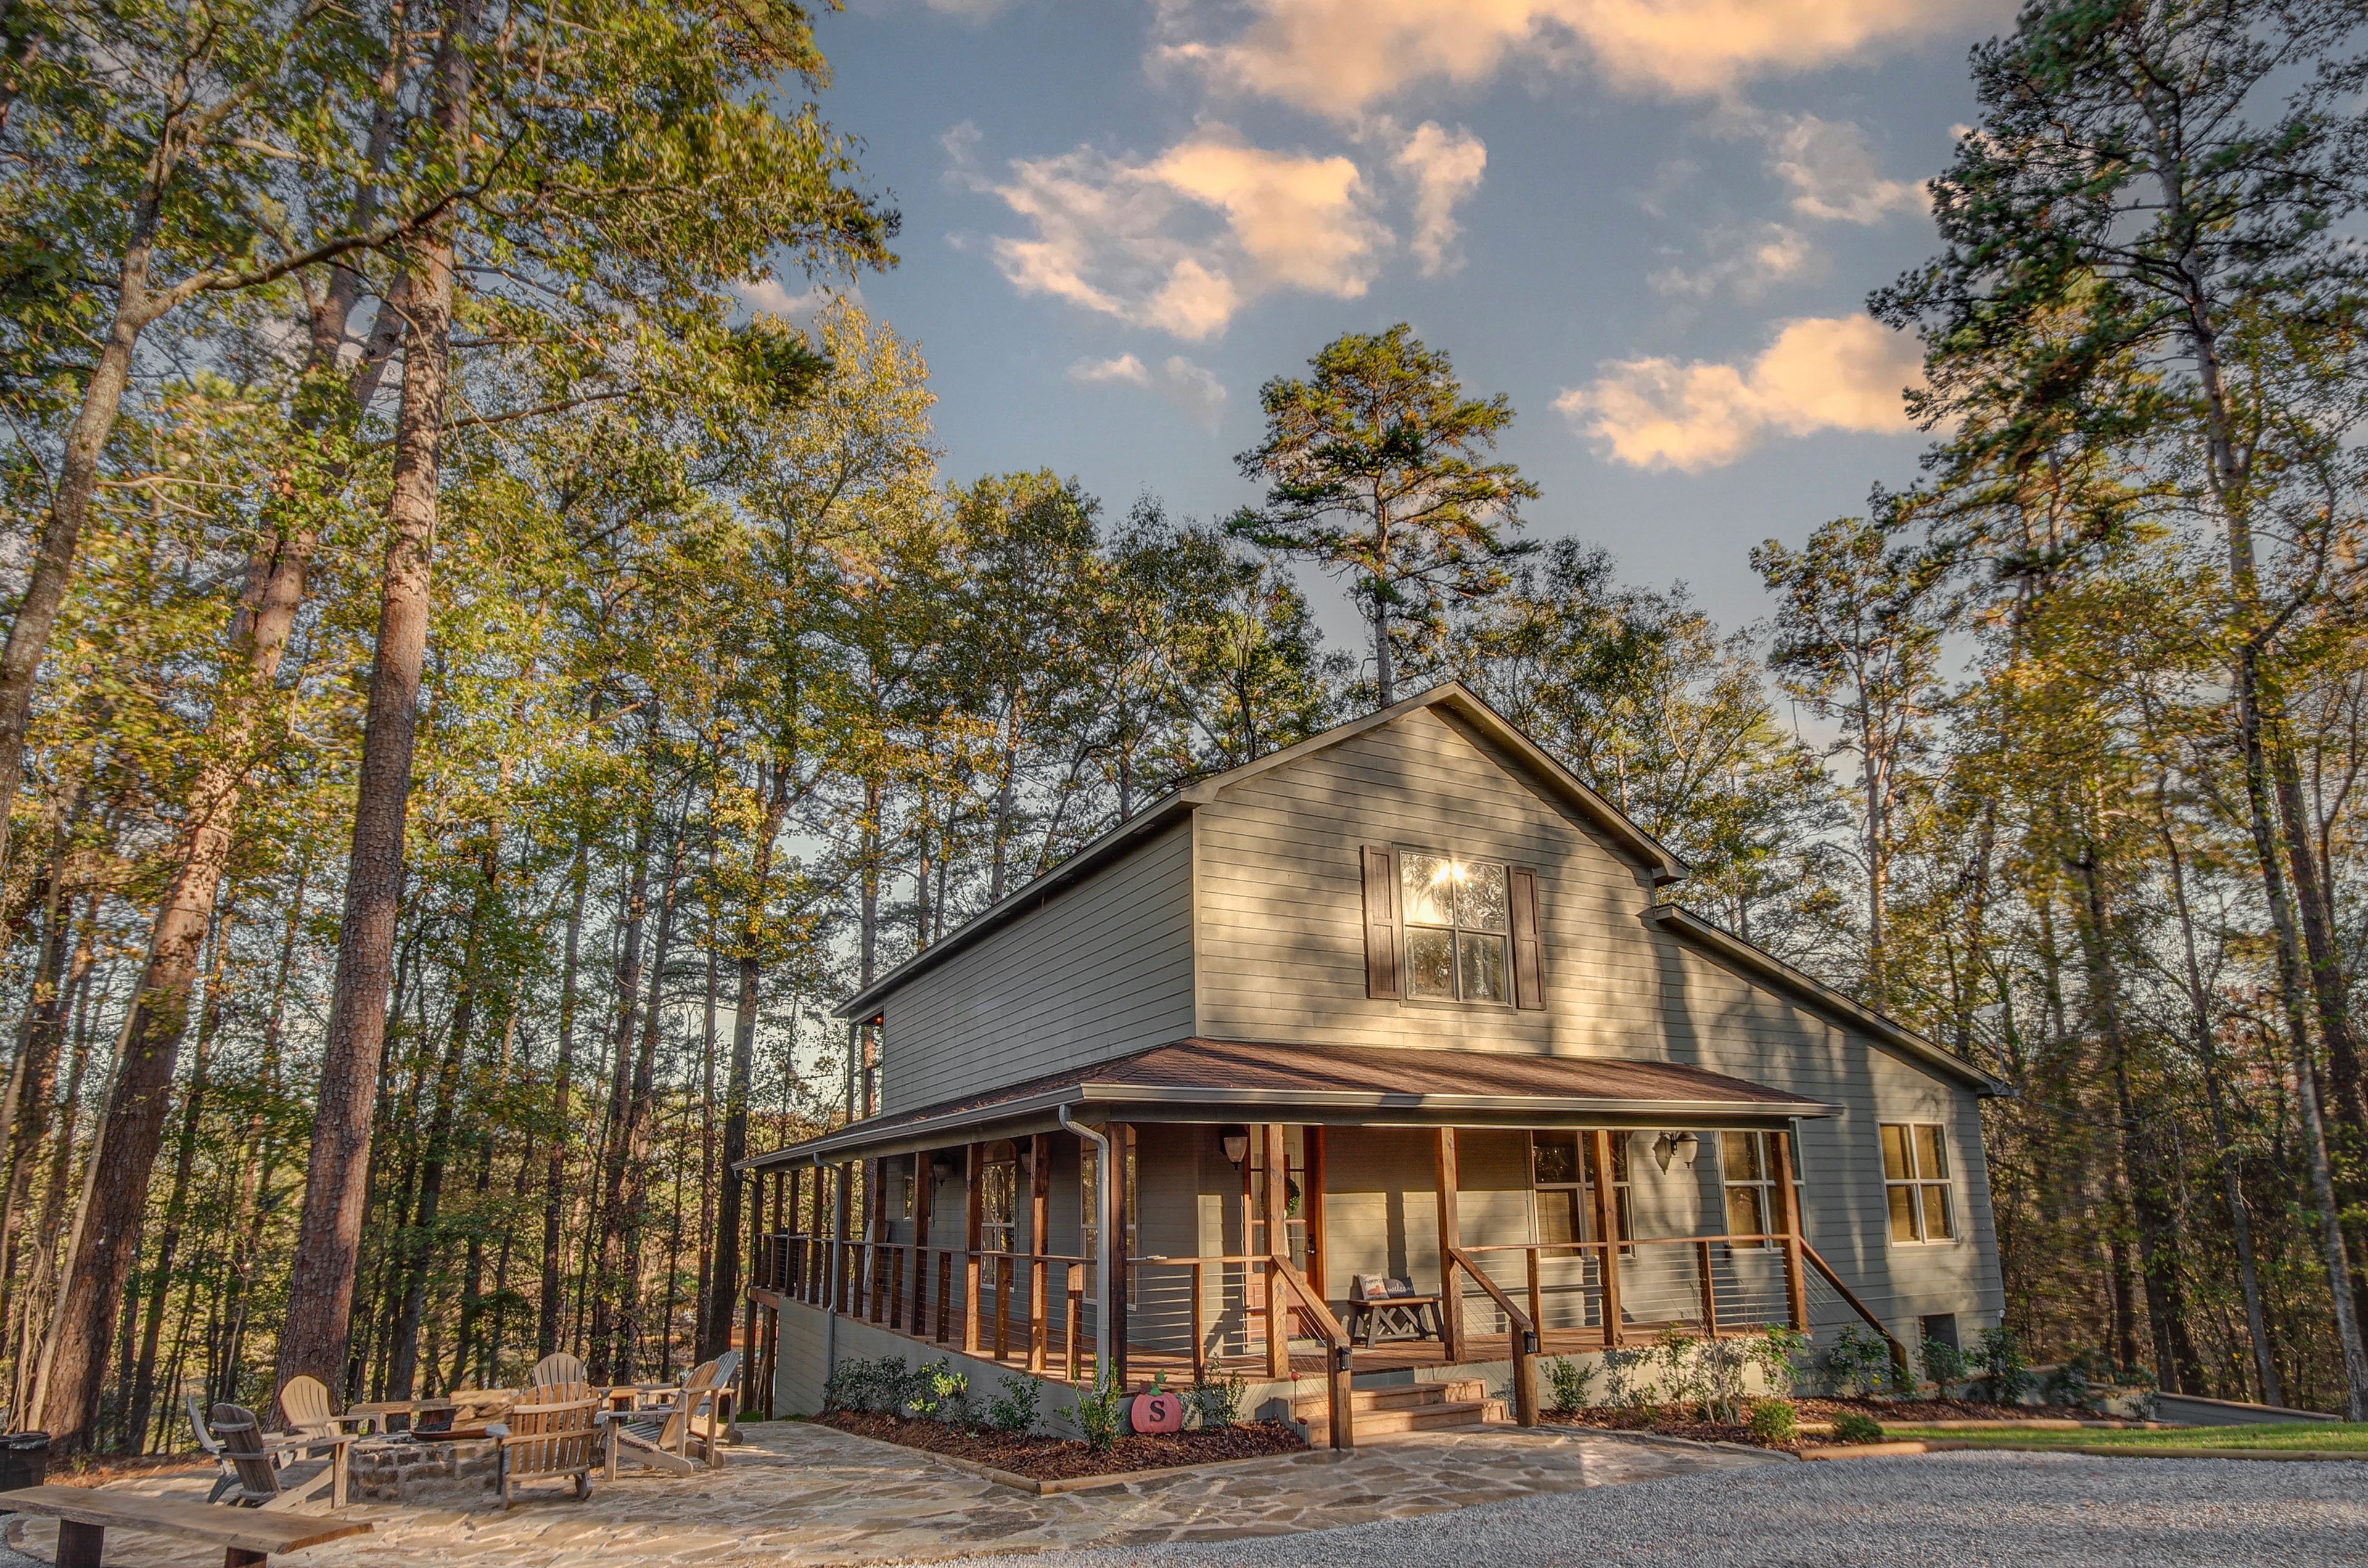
[771, 0, 2010, 634]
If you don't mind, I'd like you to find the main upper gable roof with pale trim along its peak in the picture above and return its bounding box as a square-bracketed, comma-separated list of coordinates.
[831, 679, 1686, 1019]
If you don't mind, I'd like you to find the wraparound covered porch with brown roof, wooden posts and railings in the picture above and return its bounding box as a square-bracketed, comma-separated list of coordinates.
[753, 1042, 1889, 1442]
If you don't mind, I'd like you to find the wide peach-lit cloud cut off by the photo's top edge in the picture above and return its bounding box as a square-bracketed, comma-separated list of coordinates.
[1153, 0, 2013, 116]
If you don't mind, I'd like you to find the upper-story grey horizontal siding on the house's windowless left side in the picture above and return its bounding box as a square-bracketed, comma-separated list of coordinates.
[881, 822, 1193, 1115]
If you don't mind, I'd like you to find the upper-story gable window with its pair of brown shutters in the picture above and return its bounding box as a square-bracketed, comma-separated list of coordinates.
[1364, 844, 1547, 1009]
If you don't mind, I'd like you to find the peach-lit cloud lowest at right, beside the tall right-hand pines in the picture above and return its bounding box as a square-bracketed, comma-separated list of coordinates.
[1553, 315, 1923, 474]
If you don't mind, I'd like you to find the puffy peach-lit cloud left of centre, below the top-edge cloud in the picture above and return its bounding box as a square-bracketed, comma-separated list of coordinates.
[945, 126, 1392, 339]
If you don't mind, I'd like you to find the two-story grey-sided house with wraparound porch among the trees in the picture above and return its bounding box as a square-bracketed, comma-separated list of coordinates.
[741, 684, 2004, 1442]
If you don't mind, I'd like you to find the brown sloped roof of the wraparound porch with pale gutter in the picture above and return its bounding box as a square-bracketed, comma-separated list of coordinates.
[739, 1038, 1835, 1170]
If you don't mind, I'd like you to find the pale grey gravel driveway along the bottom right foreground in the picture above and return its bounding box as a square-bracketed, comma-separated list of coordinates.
[937, 1455, 2368, 1568]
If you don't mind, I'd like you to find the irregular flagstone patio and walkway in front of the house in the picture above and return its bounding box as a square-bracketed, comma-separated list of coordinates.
[0, 1421, 1790, 1568]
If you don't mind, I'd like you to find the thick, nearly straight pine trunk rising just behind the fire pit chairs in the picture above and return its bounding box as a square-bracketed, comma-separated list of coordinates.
[277, 0, 483, 1385]
